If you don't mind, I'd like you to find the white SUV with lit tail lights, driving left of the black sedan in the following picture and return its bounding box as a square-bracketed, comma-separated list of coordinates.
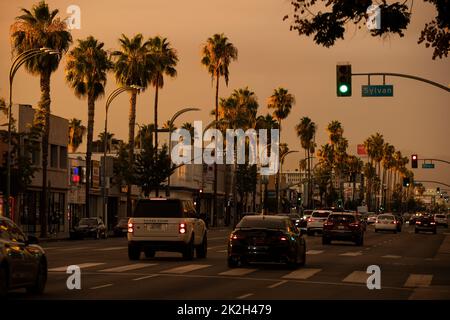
[128, 198, 208, 260]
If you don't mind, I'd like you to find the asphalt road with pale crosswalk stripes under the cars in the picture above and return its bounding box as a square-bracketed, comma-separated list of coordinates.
[9, 225, 450, 301]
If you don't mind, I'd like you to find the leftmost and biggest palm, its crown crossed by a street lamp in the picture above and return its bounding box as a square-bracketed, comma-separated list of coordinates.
[11, 1, 72, 237]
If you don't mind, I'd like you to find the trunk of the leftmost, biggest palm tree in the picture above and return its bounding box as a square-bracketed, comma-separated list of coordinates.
[35, 72, 51, 238]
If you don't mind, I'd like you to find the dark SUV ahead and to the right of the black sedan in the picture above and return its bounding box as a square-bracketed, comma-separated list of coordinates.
[322, 213, 364, 246]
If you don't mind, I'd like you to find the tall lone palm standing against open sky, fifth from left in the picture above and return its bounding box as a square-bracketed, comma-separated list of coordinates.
[201, 33, 238, 225]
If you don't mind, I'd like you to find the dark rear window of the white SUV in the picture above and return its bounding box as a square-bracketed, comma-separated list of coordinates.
[133, 200, 183, 218]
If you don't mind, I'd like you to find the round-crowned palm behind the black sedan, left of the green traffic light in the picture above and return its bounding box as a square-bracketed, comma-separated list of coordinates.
[267, 88, 295, 210]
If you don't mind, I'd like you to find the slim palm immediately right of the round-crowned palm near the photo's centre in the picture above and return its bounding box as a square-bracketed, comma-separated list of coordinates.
[295, 117, 317, 208]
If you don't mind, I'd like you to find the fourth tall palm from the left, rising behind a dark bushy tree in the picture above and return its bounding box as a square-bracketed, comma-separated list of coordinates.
[148, 36, 178, 152]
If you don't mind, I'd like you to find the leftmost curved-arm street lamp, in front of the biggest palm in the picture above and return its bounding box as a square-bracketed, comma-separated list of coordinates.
[5, 47, 59, 217]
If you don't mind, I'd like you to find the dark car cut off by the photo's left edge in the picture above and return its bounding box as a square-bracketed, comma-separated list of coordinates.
[0, 216, 48, 297]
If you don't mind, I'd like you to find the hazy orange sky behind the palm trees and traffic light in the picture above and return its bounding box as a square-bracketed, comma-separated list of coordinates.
[0, 0, 450, 190]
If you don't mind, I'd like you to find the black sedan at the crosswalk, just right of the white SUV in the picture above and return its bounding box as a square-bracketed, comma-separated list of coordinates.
[228, 215, 306, 268]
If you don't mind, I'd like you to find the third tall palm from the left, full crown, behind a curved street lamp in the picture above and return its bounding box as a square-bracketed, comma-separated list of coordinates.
[112, 33, 153, 216]
